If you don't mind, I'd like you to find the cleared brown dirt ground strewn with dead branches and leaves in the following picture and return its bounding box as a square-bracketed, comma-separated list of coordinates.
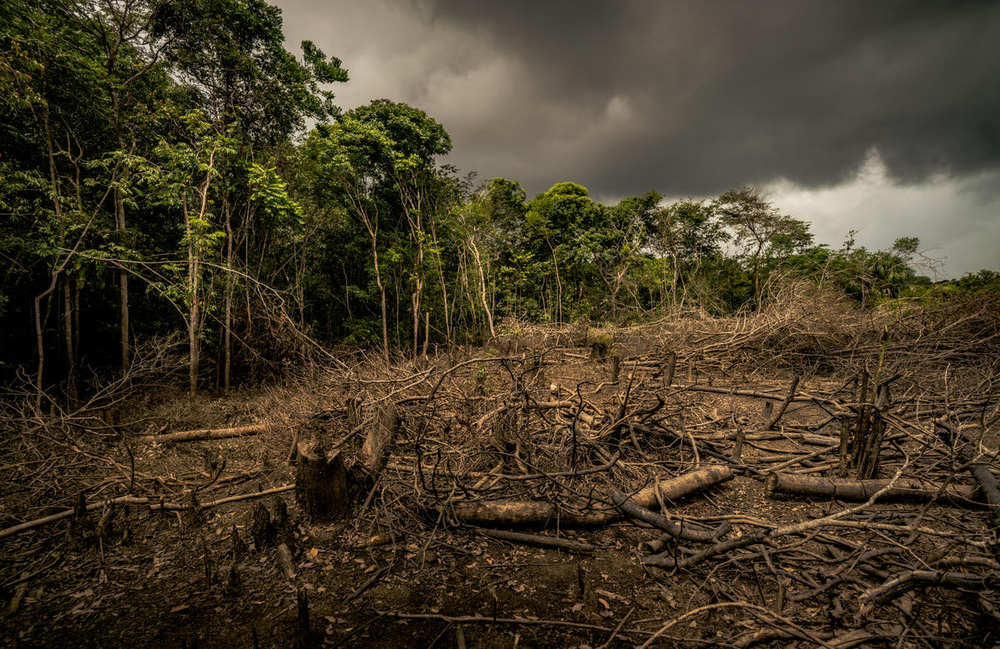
[0, 302, 1000, 648]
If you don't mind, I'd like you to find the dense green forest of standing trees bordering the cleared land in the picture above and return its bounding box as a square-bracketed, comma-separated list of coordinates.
[0, 0, 998, 403]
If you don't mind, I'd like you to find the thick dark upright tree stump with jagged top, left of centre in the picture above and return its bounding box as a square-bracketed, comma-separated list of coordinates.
[295, 444, 349, 521]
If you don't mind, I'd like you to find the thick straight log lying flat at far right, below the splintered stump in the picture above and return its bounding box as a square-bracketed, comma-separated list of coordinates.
[764, 472, 982, 507]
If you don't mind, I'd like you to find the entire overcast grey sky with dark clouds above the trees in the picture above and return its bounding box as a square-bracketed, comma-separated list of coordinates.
[272, 0, 1000, 277]
